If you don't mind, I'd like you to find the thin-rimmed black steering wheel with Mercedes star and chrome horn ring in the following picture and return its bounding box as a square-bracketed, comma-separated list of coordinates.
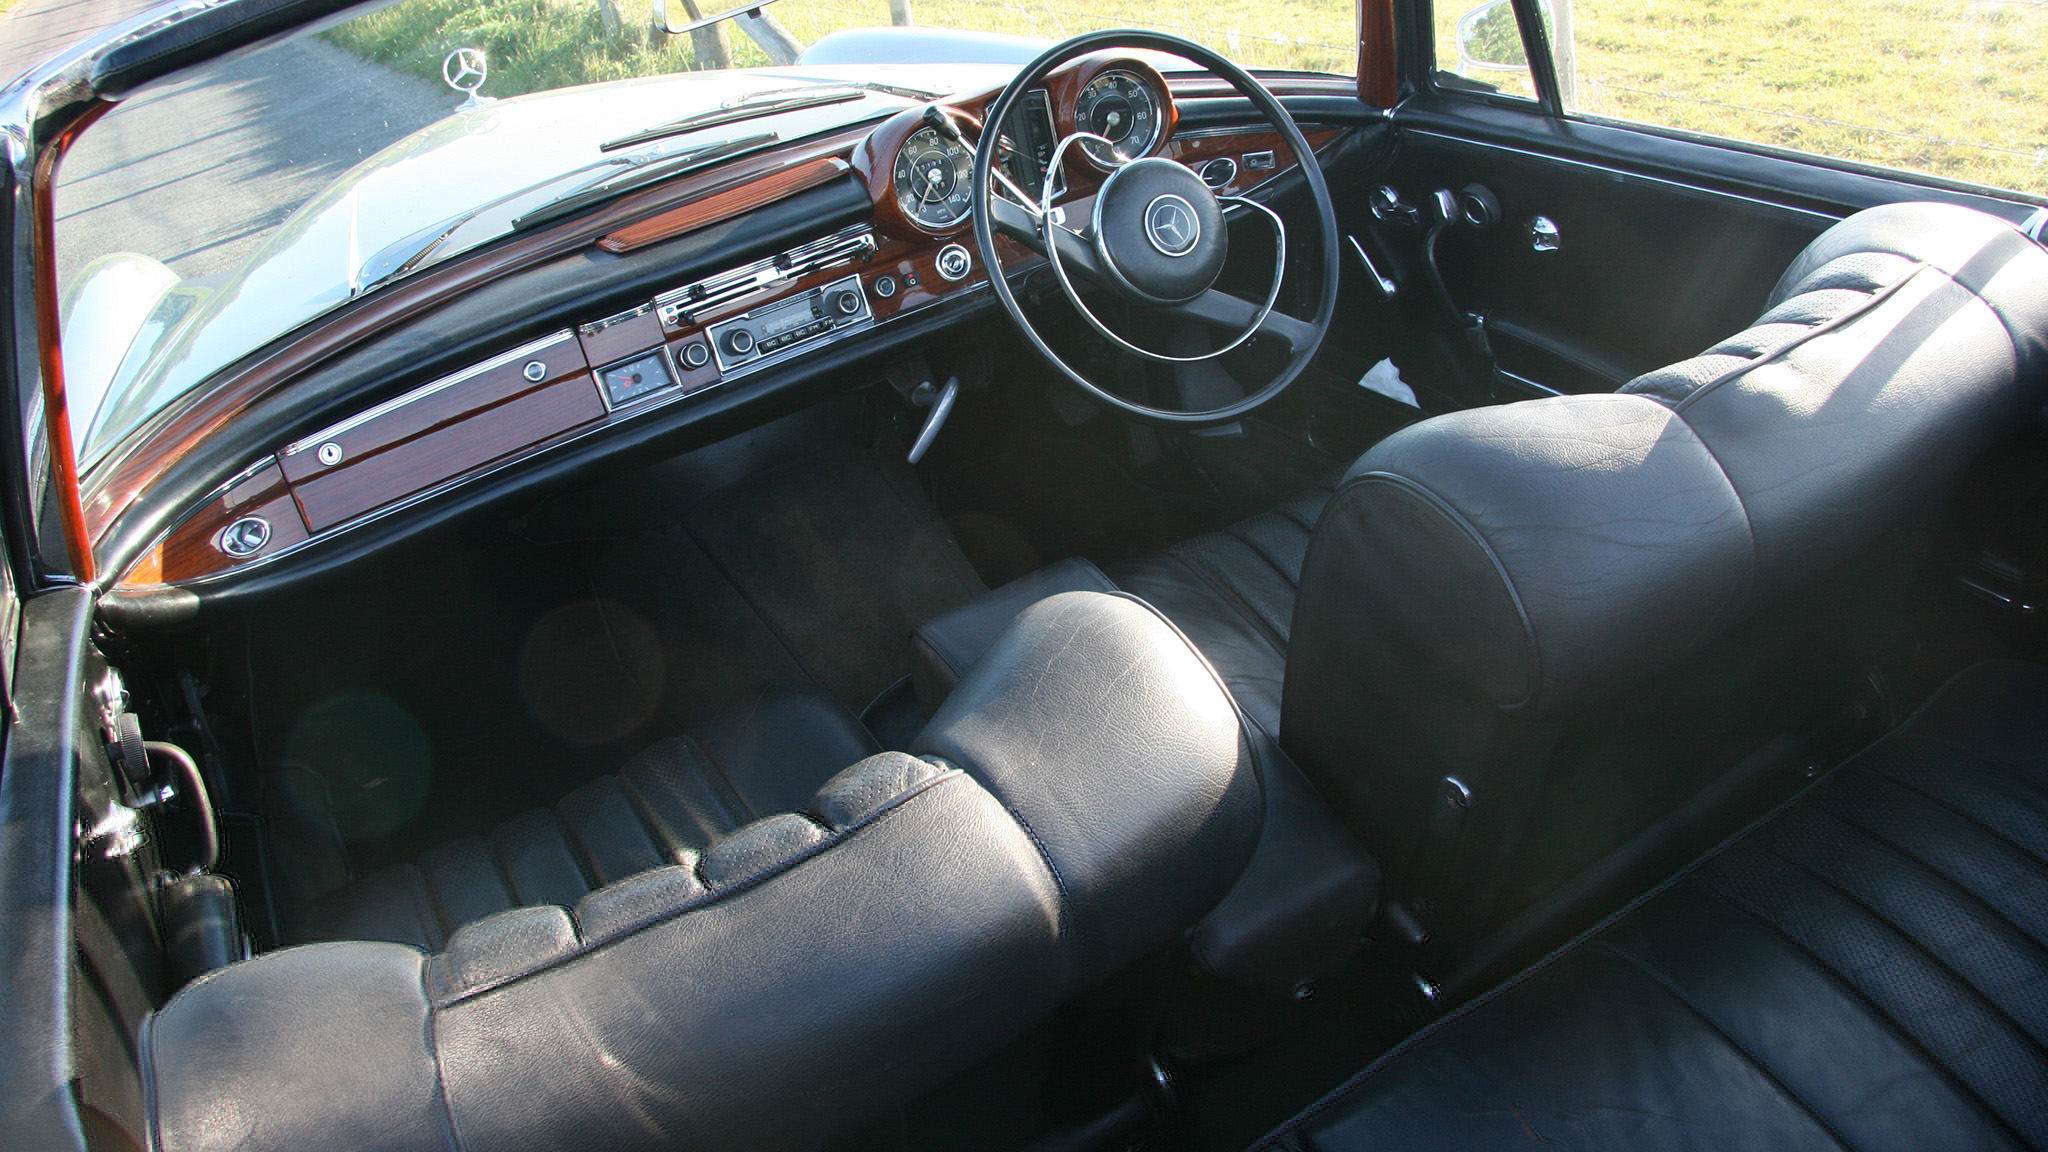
[973, 29, 1337, 424]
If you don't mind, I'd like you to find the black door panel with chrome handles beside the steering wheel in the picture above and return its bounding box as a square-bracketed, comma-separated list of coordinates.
[1372, 92, 2030, 398]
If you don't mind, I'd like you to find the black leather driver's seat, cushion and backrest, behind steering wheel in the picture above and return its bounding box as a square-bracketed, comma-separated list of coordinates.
[918, 203, 2048, 992]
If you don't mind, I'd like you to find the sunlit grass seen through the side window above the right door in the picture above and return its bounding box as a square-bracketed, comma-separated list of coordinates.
[1438, 0, 2048, 195]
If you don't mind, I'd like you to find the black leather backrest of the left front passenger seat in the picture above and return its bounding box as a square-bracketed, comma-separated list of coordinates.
[141, 594, 1262, 1152]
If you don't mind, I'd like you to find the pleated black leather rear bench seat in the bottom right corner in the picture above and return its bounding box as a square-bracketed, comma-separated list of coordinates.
[1266, 662, 2048, 1152]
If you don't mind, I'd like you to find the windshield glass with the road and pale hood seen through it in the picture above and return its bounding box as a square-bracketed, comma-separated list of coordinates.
[57, 0, 1356, 474]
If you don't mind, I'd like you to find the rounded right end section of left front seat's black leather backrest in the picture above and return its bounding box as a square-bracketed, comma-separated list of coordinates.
[911, 592, 1264, 984]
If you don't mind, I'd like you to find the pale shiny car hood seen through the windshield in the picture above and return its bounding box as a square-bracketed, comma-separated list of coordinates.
[82, 64, 1016, 467]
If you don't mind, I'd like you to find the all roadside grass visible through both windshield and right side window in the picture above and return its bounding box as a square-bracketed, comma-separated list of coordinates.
[327, 0, 2048, 195]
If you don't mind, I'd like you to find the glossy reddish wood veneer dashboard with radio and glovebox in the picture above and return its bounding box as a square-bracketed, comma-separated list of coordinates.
[121, 55, 1337, 588]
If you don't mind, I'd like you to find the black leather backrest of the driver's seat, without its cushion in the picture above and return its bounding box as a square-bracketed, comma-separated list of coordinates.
[1282, 203, 2048, 971]
